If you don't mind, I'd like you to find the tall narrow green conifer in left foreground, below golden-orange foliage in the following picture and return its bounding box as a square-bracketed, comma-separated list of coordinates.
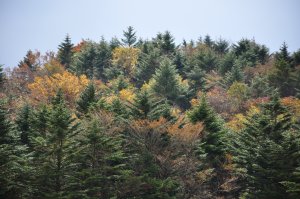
[33, 90, 78, 198]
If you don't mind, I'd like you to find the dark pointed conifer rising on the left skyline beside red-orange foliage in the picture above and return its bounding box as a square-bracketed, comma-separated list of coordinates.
[57, 34, 74, 69]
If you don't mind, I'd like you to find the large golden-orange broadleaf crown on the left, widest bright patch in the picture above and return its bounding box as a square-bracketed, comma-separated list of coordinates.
[28, 71, 89, 103]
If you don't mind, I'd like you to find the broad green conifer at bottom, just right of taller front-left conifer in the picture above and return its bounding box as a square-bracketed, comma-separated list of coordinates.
[68, 118, 132, 198]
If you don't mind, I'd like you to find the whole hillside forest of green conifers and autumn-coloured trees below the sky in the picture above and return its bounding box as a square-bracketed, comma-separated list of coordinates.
[0, 26, 300, 199]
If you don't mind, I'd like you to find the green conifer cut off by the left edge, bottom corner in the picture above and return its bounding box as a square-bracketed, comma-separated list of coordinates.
[0, 99, 31, 199]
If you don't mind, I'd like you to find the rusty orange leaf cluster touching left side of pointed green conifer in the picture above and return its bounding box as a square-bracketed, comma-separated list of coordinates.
[167, 116, 203, 142]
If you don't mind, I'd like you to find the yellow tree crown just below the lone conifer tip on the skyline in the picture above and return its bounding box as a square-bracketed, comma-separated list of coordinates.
[112, 47, 140, 74]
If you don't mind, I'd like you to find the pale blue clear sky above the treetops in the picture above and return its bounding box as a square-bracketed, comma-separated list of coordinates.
[0, 0, 300, 67]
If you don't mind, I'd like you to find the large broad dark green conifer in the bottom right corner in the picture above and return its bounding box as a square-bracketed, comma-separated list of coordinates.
[234, 93, 300, 199]
